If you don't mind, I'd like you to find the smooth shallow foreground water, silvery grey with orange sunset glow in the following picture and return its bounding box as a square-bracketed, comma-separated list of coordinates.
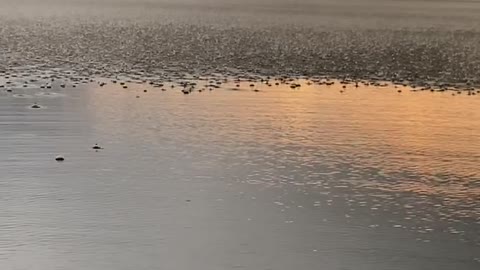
[0, 75, 480, 270]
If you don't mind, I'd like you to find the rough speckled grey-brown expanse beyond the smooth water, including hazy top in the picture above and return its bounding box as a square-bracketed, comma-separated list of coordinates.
[0, 0, 480, 87]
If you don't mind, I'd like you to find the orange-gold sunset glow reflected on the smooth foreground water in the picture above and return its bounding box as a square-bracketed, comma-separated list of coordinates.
[89, 78, 480, 207]
